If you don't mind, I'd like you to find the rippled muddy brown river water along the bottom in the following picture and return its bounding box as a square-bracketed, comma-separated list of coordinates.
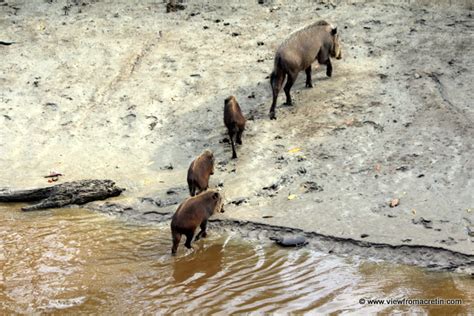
[0, 206, 474, 314]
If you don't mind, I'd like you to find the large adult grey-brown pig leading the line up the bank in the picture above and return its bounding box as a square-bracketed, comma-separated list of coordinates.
[270, 21, 342, 120]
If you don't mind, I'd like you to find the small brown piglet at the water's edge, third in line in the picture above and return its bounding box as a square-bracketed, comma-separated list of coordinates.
[188, 149, 214, 196]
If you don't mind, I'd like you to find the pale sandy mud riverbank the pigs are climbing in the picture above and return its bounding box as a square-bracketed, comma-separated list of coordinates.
[0, 1, 474, 270]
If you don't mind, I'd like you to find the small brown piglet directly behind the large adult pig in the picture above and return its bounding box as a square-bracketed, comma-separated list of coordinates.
[224, 96, 245, 159]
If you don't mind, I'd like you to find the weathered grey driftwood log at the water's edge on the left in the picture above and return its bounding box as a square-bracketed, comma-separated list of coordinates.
[0, 180, 125, 211]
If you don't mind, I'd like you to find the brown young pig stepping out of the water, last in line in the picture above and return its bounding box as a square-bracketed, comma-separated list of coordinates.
[171, 190, 224, 255]
